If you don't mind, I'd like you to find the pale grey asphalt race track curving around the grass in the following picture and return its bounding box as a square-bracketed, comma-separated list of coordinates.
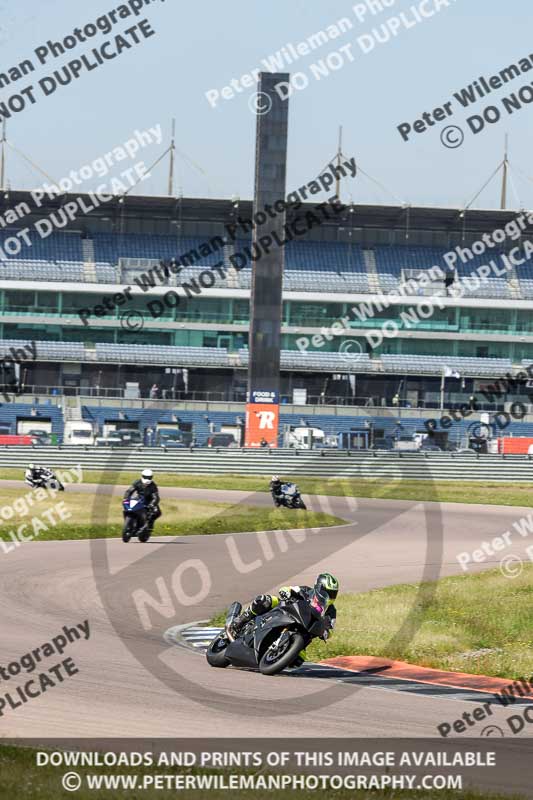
[0, 481, 529, 788]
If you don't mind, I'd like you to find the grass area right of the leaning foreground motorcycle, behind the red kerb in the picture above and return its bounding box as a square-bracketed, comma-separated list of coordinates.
[211, 565, 533, 680]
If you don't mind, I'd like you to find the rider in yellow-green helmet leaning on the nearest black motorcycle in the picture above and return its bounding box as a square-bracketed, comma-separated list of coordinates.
[230, 572, 339, 663]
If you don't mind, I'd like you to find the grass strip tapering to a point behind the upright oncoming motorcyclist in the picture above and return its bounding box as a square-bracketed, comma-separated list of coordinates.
[0, 488, 345, 546]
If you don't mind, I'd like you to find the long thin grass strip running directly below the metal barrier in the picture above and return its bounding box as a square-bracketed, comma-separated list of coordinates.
[0, 466, 531, 506]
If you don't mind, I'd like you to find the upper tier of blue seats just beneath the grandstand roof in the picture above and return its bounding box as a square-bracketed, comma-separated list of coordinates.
[0, 230, 520, 298]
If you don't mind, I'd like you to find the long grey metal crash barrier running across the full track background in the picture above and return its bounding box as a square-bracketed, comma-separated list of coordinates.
[0, 446, 533, 481]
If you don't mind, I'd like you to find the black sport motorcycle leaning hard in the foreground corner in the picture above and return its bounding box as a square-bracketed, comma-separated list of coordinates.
[206, 596, 327, 675]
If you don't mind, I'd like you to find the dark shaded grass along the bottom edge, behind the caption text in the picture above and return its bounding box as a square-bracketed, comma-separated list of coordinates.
[0, 739, 518, 800]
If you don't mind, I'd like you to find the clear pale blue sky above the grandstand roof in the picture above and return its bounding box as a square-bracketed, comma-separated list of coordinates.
[0, 0, 533, 208]
